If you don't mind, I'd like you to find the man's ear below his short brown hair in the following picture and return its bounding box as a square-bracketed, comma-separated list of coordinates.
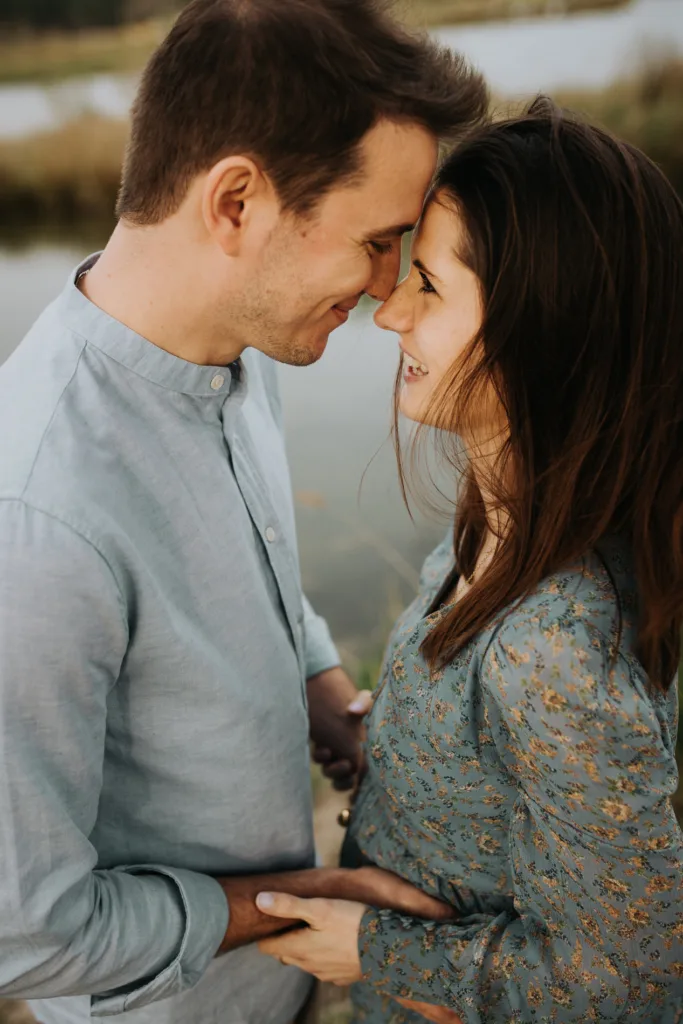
[202, 156, 274, 256]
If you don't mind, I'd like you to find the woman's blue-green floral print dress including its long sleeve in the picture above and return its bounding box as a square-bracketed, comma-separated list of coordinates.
[349, 541, 683, 1024]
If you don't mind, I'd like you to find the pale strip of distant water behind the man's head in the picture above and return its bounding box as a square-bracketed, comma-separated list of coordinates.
[0, 0, 683, 138]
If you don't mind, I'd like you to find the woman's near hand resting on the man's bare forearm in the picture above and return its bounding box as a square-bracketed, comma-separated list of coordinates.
[256, 893, 368, 985]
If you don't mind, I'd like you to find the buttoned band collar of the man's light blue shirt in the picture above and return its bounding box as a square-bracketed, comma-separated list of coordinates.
[60, 253, 244, 399]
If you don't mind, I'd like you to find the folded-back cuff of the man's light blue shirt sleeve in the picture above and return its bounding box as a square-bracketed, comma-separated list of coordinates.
[90, 864, 229, 1017]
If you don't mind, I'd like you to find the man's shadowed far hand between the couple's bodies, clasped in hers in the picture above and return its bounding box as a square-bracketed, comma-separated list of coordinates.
[306, 668, 373, 790]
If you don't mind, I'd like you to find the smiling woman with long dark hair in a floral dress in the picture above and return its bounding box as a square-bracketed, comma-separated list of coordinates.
[255, 100, 683, 1024]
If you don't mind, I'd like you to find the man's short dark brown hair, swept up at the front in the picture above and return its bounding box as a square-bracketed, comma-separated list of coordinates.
[117, 0, 487, 224]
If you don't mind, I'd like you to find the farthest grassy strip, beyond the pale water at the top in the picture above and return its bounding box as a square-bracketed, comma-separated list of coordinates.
[0, 0, 628, 82]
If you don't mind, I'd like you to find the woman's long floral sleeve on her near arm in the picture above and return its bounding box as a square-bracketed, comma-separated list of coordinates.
[359, 622, 683, 1024]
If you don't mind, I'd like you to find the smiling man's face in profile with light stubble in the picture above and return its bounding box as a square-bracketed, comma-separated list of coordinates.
[233, 122, 437, 366]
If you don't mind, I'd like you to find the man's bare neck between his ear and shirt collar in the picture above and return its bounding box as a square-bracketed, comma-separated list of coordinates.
[79, 222, 244, 366]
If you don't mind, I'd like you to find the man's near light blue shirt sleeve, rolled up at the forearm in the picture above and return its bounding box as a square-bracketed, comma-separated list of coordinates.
[0, 501, 228, 1016]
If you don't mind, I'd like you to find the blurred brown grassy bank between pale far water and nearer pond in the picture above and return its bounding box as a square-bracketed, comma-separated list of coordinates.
[0, 58, 683, 231]
